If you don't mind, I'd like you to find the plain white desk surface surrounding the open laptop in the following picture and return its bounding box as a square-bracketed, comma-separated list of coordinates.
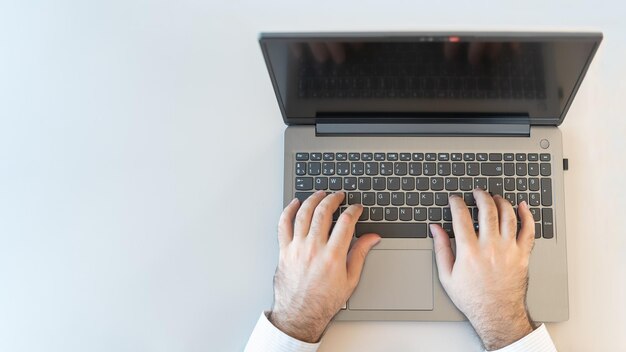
[0, 0, 626, 352]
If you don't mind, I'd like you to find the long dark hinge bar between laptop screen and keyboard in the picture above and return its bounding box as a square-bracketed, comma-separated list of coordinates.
[315, 121, 530, 137]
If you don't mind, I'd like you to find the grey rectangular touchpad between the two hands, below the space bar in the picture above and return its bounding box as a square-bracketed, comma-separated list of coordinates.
[348, 249, 433, 310]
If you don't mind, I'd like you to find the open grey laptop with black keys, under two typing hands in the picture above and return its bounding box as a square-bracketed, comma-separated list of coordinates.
[260, 32, 602, 322]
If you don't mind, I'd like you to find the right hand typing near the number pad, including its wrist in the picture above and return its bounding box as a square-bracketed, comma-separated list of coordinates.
[431, 189, 535, 350]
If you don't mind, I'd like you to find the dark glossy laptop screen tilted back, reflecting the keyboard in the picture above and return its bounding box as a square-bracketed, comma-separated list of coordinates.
[260, 33, 601, 124]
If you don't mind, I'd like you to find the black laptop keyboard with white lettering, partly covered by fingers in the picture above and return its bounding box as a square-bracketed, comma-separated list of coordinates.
[294, 152, 554, 239]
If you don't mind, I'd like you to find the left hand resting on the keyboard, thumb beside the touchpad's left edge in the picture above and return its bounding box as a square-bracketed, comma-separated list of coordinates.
[268, 191, 380, 342]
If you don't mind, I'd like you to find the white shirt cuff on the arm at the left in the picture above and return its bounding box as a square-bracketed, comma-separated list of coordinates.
[244, 312, 320, 352]
